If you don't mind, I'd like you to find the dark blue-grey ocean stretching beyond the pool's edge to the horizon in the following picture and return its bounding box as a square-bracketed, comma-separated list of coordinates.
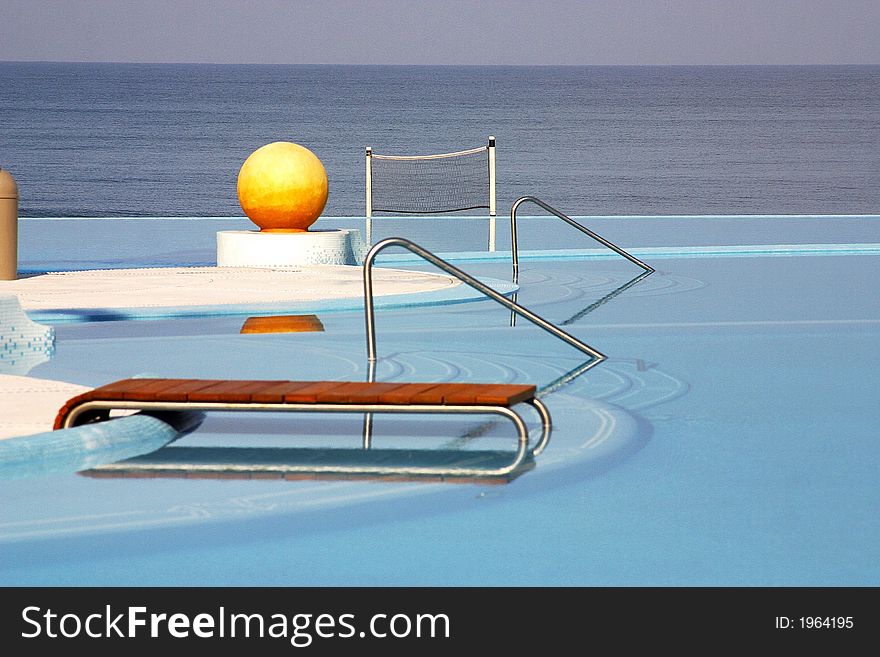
[0, 62, 880, 218]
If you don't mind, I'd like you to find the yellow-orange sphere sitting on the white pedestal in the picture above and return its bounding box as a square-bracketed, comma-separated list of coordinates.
[238, 141, 328, 232]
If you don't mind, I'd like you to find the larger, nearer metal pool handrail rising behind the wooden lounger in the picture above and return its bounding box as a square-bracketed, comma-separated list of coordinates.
[364, 237, 606, 365]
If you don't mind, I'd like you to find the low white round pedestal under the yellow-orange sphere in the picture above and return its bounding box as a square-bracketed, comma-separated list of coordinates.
[217, 229, 358, 267]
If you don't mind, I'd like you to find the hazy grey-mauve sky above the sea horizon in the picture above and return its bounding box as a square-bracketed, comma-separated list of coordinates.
[0, 0, 880, 65]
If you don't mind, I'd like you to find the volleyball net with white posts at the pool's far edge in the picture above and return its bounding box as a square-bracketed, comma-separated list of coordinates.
[366, 137, 495, 251]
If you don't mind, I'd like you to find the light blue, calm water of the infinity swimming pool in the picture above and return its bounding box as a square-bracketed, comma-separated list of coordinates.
[0, 216, 880, 586]
